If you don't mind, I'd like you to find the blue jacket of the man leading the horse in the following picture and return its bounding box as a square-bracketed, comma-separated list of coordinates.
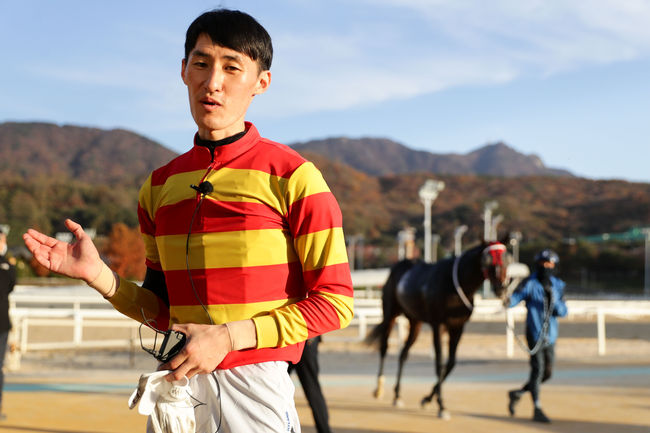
[508, 272, 568, 344]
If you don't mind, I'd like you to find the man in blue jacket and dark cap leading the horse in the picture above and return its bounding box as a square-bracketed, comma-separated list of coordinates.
[507, 249, 567, 423]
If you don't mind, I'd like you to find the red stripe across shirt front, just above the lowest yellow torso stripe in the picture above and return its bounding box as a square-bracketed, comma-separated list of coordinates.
[165, 262, 305, 305]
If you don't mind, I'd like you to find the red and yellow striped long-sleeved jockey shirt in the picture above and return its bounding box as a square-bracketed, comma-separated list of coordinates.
[111, 123, 353, 368]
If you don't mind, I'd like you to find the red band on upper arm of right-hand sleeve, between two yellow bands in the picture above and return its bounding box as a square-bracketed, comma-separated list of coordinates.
[288, 192, 343, 237]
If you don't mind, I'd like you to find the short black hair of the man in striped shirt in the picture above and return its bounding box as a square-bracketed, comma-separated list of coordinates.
[185, 9, 273, 71]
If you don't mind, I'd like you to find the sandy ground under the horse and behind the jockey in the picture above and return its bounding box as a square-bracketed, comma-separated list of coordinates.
[0, 321, 650, 433]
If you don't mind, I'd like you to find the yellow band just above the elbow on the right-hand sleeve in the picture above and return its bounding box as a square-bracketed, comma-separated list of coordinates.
[295, 227, 348, 271]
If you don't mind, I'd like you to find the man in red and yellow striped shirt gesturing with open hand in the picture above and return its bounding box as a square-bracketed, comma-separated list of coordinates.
[24, 9, 353, 432]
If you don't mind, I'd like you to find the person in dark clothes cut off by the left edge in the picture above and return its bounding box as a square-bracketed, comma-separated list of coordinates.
[0, 227, 16, 420]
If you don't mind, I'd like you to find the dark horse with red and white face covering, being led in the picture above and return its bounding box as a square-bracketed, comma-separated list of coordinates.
[366, 242, 507, 418]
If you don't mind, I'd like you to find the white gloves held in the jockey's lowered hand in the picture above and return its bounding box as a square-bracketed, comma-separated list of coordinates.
[129, 370, 196, 433]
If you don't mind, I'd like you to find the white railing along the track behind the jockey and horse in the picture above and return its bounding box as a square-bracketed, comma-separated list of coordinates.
[10, 269, 650, 357]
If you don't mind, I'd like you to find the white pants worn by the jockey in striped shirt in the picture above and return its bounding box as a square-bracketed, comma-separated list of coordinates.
[190, 361, 300, 433]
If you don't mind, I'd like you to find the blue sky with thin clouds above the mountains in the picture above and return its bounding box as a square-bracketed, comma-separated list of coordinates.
[0, 0, 650, 182]
